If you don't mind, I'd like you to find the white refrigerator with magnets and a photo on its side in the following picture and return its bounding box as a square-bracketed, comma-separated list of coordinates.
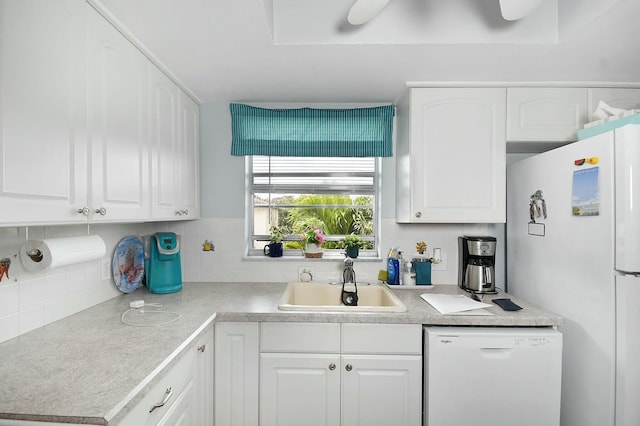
[506, 115, 640, 426]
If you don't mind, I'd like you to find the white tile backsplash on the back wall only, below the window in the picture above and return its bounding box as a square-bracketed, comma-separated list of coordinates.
[170, 218, 496, 284]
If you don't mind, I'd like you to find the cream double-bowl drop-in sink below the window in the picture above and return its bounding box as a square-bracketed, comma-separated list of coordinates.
[278, 283, 407, 312]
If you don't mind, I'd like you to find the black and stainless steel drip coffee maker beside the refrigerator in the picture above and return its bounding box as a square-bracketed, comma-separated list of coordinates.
[458, 235, 496, 293]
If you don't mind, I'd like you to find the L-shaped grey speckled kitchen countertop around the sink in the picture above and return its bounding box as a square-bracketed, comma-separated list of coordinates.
[0, 283, 562, 425]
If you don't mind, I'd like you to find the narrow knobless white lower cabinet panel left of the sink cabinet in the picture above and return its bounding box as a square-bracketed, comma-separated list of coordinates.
[215, 322, 260, 426]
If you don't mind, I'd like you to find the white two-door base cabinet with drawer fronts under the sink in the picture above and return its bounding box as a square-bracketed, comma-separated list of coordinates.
[260, 323, 422, 426]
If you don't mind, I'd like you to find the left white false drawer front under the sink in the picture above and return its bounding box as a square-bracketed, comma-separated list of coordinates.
[260, 322, 340, 353]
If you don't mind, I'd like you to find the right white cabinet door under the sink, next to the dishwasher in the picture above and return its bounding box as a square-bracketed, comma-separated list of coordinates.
[342, 355, 422, 426]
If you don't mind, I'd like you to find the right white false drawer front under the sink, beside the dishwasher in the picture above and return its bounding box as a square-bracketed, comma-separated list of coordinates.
[342, 324, 422, 355]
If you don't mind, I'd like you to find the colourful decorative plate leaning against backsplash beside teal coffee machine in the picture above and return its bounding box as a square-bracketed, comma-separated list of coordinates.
[111, 235, 144, 293]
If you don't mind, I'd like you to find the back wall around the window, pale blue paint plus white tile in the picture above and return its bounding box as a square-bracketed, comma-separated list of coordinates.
[195, 102, 505, 286]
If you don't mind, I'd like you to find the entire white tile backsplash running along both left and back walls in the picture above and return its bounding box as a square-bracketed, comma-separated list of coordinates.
[0, 218, 503, 342]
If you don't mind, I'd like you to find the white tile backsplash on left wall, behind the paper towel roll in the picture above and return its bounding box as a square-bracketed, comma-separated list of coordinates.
[0, 224, 162, 342]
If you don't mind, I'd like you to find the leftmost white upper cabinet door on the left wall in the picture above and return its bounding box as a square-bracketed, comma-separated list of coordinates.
[0, 0, 87, 225]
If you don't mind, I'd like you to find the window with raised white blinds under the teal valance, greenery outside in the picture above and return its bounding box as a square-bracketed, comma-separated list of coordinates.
[247, 156, 380, 257]
